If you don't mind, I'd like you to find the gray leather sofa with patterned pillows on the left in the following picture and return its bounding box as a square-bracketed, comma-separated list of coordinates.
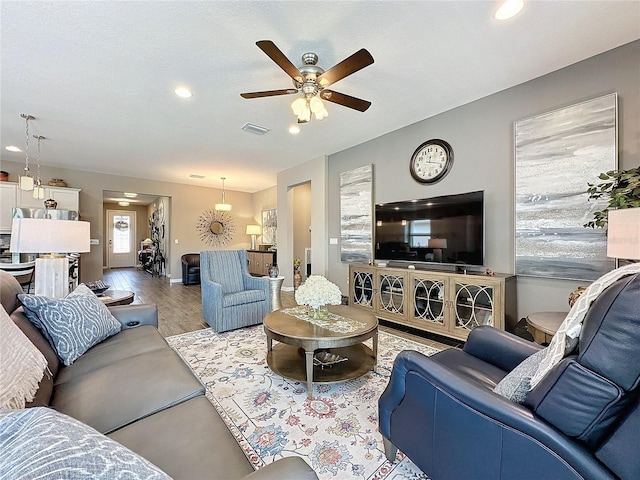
[0, 271, 317, 480]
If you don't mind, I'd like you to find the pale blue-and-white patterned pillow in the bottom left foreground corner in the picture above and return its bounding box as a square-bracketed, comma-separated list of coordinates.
[0, 407, 170, 480]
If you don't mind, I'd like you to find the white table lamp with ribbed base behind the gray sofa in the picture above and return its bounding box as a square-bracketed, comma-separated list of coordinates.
[9, 218, 91, 298]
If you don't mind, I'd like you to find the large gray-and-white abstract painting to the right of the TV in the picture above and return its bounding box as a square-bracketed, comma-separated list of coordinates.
[514, 93, 618, 281]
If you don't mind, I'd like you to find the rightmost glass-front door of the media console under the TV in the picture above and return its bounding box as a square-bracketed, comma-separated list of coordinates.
[449, 277, 504, 339]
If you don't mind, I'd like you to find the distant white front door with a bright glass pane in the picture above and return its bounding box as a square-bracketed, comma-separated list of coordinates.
[107, 210, 137, 268]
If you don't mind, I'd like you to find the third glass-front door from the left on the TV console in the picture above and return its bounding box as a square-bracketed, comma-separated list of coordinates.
[409, 273, 450, 333]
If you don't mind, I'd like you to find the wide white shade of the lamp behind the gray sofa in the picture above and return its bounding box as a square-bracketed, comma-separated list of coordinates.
[9, 218, 91, 253]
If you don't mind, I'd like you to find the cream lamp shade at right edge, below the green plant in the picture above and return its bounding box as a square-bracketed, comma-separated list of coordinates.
[607, 208, 640, 260]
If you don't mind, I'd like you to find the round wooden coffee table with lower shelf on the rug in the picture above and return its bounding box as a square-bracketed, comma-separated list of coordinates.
[263, 305, 378, 398]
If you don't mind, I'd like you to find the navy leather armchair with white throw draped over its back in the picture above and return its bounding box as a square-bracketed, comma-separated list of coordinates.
[378, 275, 640, 480]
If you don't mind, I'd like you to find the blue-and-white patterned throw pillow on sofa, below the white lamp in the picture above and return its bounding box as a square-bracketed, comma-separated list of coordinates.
[18, 284, 121, 365]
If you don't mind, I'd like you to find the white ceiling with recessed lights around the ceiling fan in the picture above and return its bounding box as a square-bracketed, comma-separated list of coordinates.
[0, 0, 640, 192]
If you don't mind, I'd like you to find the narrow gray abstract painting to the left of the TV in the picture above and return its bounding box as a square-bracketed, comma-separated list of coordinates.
[340, 165, 373, 263]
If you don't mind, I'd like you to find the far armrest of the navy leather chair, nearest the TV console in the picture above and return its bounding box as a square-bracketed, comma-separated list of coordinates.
[463, 325, 544, 372]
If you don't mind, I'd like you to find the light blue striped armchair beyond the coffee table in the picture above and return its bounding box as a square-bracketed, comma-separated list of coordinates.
[200, 250, 271, 332]
